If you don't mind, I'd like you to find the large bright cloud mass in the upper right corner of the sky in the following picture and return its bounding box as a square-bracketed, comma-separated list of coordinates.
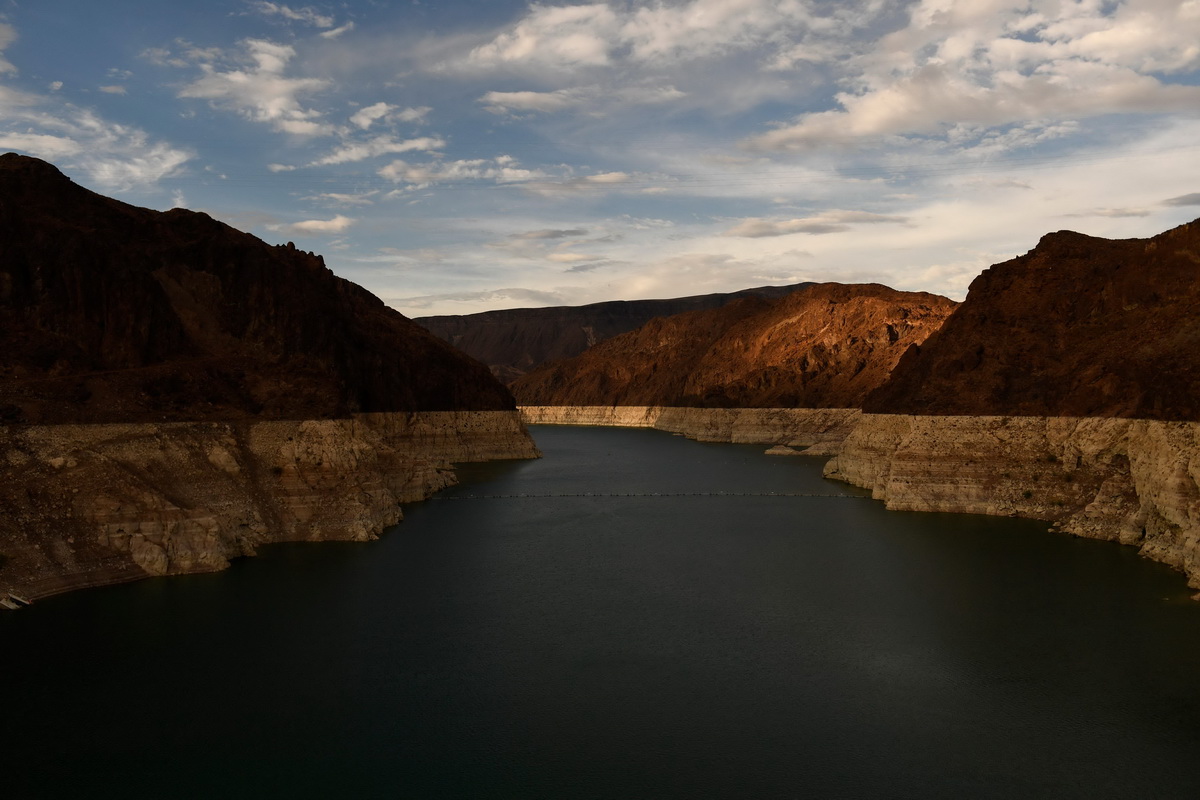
[745, 0, 1200, 151]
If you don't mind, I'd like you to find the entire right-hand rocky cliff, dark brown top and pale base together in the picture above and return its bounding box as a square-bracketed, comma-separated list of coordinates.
[827, 222, 1200, 599]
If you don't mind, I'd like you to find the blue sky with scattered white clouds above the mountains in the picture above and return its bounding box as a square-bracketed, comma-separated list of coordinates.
[0, 0, 1200, 317]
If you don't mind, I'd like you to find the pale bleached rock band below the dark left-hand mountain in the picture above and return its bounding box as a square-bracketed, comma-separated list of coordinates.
[0, 411, 539, 603]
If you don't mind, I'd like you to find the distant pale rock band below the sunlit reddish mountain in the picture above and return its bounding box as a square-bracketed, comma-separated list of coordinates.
[521, 405, 862, 453]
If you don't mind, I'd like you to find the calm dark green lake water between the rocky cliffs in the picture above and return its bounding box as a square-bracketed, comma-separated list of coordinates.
[0, 428, 1200, 798]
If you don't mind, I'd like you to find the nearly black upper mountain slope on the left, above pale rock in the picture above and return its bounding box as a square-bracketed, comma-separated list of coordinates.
[0, 154, 512, 422]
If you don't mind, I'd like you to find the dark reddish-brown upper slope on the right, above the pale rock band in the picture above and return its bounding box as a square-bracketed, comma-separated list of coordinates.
[864, 221, 1200, 420]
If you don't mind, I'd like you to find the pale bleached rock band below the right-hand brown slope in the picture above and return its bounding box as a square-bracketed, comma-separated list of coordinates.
[826, 414, 1200, 599]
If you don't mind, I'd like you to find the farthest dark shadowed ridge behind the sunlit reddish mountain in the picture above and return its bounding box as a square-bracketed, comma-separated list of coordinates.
[413, 283, 811, 381]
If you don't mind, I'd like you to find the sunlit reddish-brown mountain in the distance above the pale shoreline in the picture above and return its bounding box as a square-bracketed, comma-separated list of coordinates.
[512, 283, 955, 408]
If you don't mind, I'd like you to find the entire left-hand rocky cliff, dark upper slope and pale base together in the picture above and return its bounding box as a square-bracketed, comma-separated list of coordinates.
[0, 154, 538, 604]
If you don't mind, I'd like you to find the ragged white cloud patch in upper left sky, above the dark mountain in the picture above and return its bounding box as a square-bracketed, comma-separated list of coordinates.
[179, 38, 334, 136]
